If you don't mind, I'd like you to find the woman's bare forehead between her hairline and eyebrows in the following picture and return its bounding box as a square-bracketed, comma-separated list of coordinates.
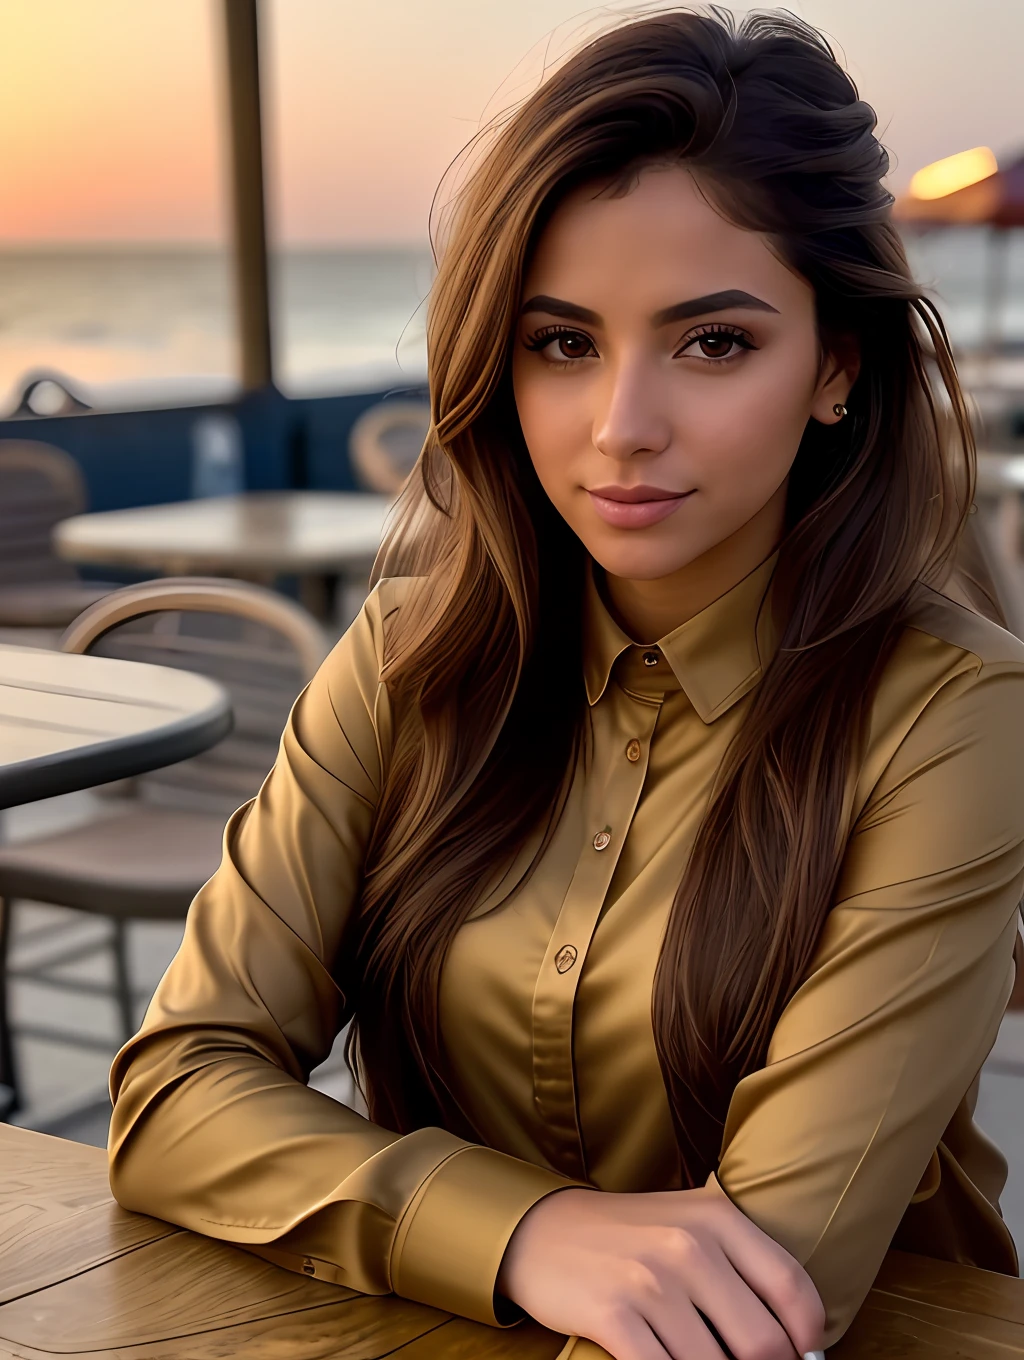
[524, 166, 812, 310]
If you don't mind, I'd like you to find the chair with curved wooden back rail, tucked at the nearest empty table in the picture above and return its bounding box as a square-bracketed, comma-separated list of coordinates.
[0, 577, 328, 1118]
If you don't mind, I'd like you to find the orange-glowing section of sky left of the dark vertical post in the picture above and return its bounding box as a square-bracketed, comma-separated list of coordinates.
[0, 0, 224, 241]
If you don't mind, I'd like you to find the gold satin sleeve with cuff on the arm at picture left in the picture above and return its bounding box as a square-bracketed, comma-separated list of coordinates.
[110, 582, 571, 1323]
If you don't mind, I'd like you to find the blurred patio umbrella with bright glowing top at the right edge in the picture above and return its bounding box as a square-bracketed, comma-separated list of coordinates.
[893, 147, 1024, 354]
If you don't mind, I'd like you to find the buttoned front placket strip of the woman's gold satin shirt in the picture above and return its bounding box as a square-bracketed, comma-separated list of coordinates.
[533, 688, 661, 1176]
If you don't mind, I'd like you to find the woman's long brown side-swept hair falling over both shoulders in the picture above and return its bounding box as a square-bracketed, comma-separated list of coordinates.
[341, 7, 974, 1185]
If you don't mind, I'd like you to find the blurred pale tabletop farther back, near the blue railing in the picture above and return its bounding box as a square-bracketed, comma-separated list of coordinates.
[53, 491, 390, 617]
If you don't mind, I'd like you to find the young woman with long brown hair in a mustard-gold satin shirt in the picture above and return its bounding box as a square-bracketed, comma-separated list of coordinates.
[110, 11, 1024, 1360]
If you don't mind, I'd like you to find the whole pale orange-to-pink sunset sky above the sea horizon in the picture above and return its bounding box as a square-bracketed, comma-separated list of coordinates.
[0, 0, 1024, 243]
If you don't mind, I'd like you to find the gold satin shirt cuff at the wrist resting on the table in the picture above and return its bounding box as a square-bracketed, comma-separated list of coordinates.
[390, 1145, 582, 1327]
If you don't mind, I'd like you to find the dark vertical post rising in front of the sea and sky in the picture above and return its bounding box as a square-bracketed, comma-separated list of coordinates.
[223, 0, 273, 392]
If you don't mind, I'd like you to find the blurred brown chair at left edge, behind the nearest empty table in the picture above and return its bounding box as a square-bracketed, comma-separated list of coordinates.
[0, 439, 114, 642]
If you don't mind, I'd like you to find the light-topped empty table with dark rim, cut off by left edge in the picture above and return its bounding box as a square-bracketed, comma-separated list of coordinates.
[0, 643, 231, 808]
